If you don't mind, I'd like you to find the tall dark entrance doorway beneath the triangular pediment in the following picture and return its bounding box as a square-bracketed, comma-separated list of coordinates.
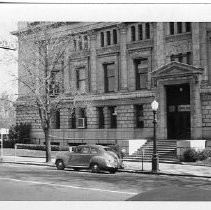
[166, 84, 191, 139]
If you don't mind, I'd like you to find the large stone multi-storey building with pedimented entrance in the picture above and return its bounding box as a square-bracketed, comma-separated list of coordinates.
[14, 22, 211, 153]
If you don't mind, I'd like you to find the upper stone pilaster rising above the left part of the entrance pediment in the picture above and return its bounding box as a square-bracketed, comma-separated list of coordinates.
[154, 22, 166, 69]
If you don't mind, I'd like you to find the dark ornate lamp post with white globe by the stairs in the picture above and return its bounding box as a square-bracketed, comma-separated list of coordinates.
[151, 100, 159, 173]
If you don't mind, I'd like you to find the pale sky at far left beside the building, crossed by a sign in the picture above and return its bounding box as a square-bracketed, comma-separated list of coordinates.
[0, 20, 18, 95]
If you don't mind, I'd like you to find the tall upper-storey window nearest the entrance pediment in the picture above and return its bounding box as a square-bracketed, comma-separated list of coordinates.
[135, 58, 148, 90]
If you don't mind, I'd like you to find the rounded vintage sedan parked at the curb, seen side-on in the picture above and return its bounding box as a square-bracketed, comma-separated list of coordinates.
[55, 145, 118, 173]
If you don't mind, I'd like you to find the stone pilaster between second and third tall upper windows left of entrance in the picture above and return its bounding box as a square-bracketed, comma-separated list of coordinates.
[89, 30, 97, 93]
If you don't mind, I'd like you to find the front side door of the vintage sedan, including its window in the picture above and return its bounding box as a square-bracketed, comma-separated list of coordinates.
[69, 146, 90, 167]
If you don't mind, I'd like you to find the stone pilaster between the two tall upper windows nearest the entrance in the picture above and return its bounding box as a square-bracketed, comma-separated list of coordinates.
[119, 23, 127, 90]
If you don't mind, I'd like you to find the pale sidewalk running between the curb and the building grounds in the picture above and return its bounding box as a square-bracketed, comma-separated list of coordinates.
[2, 156, 211, 178]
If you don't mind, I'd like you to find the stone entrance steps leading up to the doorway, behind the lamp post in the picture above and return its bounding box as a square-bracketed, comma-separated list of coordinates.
[124, 140, 179, 162]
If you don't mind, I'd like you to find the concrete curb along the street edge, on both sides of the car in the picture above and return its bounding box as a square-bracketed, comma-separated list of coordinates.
[1, 161, 211, 179]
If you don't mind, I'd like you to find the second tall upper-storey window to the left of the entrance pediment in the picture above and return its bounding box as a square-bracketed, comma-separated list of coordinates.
[104, 63, 115, 93]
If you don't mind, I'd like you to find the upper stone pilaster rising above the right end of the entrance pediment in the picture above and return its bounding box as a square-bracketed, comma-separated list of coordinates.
[192, 23, 200, 67]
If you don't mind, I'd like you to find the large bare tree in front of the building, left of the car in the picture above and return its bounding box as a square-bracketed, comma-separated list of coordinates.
[10, 22, 91, 162]
